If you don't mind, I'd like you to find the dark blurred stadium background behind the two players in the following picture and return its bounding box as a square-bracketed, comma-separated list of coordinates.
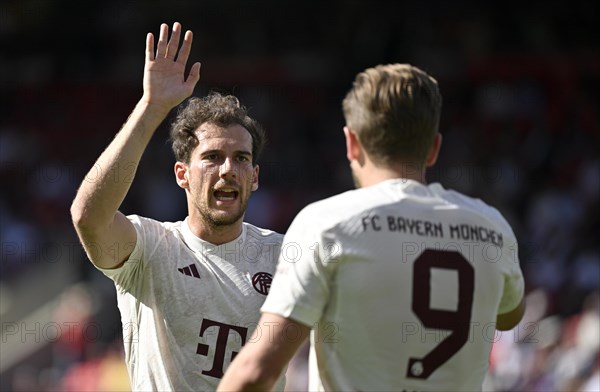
[0, 0, 600, 391]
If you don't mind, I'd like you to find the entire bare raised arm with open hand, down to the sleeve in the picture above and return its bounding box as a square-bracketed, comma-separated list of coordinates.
[71, 23, 200, 268]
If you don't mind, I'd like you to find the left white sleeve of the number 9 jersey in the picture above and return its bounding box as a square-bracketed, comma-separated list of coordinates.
[261, 209, 340, 326]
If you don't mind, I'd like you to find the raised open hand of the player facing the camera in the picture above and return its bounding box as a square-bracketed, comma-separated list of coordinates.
[143, 22, 200, 111]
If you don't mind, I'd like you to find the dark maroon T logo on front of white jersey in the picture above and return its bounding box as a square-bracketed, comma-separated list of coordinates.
[196, 319, 248, 378]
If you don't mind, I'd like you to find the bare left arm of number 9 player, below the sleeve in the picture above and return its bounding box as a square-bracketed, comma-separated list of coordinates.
[217, 313, 310, 391]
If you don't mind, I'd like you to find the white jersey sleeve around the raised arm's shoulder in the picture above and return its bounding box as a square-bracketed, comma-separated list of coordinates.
[96, 215, 155, 290]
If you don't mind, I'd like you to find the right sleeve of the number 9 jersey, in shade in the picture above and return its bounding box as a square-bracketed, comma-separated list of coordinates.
[498, 231, 525, 314]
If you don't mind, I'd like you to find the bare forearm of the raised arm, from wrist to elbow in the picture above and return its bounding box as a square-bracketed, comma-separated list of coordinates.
[71, 100, 168, 229]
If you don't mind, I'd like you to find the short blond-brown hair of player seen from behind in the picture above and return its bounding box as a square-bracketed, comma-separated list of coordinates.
[343, 64, 442, 166]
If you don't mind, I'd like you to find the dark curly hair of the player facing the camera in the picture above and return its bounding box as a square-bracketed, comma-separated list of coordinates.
[170, 92, 265, 165]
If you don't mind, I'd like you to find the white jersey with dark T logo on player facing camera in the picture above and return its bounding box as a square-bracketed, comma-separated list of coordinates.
[101, 215, 285, 391]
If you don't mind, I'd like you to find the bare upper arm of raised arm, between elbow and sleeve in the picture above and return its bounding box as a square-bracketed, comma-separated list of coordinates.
[75, 211, 137, 269]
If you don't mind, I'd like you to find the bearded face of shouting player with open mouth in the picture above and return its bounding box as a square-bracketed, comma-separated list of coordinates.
[187, 123, 258, 227]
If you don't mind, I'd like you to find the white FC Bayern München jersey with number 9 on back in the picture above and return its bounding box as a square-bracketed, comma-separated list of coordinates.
[261, 179, 524, 391]
